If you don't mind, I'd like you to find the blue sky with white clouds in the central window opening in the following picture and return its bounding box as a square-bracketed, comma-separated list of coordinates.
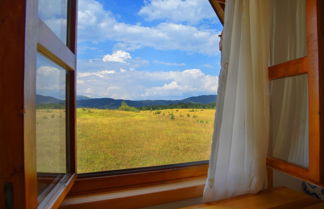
[77, 0, 222, 100]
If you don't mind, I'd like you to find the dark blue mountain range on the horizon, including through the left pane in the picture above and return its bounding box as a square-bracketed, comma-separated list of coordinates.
[36, 95, 217, 109]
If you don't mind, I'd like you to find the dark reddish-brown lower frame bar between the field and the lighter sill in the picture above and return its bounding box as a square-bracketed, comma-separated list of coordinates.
[69, 161, 208, 196]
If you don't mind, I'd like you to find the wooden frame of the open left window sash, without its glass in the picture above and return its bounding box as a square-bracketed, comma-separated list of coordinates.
[0, 0, 77, 209]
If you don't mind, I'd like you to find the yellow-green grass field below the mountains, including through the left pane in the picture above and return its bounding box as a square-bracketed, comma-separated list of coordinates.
[36, 108, 215, 173]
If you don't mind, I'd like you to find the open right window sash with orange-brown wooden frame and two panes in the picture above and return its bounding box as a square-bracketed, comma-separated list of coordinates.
[268, 0, 323, 184]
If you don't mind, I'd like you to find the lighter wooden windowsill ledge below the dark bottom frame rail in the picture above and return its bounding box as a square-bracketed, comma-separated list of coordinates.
[61, 176, 206, 209]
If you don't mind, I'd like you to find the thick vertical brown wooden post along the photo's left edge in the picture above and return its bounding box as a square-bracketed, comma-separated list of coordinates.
[0, 0, 37, 209]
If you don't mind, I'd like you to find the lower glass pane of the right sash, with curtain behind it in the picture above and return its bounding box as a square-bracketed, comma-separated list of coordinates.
[270, 74, 308, 168]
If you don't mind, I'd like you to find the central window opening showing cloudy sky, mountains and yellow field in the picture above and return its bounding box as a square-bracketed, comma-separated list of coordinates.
[77, 0, 222, 173]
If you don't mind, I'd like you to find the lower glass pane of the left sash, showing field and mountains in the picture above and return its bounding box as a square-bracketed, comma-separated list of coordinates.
[36, 54, 67, 199]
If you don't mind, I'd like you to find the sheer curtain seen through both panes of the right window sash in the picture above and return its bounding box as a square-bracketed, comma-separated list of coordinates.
[270, 0, 308, 168]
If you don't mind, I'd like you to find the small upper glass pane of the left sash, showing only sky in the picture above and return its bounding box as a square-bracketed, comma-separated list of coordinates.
[38, 0, 68, 43]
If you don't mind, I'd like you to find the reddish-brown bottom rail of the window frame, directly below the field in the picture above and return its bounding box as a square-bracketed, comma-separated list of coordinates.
[69, 163, 208, 196]
